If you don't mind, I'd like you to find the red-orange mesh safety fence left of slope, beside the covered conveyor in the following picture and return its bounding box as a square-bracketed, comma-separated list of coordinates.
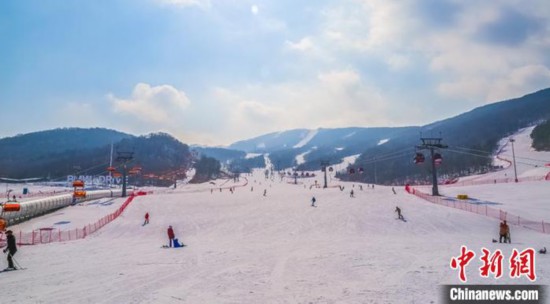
[0, 191, 151, 246]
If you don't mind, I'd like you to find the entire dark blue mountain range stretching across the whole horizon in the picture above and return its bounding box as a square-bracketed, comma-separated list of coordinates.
[0, 88, 550, 184]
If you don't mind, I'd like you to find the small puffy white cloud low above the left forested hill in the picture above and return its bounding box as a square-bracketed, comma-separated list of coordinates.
[108, 83, 190, 126]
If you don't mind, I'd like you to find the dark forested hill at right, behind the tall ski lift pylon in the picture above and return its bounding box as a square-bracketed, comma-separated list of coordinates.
[350, 89, 550, 183]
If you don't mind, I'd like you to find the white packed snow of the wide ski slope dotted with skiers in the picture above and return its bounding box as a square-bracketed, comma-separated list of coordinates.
[0, 127, 550, 304]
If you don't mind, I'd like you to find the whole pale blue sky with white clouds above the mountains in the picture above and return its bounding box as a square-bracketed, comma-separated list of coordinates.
[0, 0, 550, 145]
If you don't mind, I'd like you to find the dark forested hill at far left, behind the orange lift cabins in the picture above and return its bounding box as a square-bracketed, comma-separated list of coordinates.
[0, 128, 191, 180]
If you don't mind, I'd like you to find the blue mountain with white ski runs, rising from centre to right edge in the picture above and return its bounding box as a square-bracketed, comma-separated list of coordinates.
[225, 89, 550, 183]
